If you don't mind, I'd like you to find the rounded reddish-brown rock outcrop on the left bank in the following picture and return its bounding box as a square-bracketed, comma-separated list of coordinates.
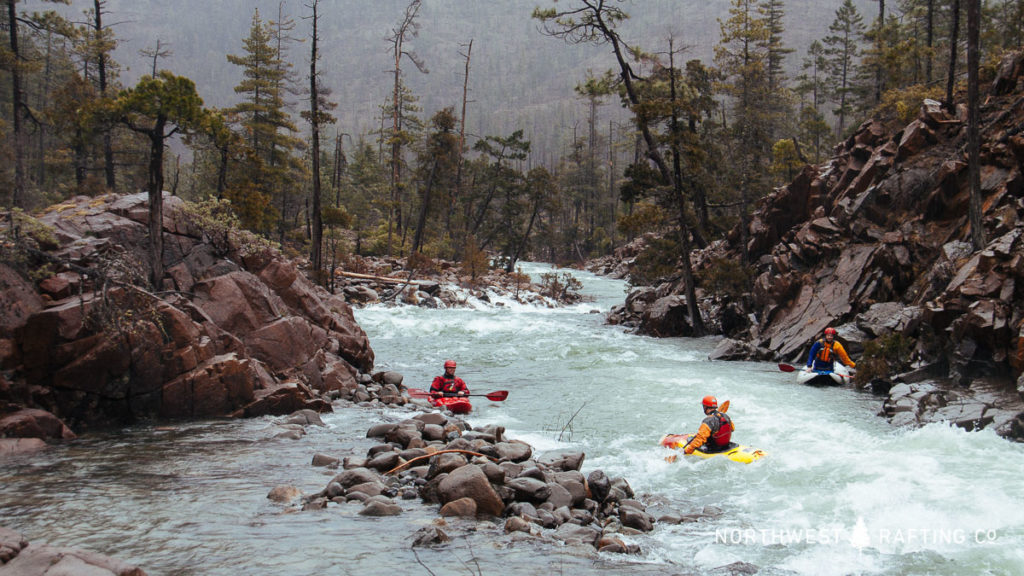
[0, 194, 374, 437]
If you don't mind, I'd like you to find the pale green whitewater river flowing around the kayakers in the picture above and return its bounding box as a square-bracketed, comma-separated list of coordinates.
[0, 264, 1024, 575]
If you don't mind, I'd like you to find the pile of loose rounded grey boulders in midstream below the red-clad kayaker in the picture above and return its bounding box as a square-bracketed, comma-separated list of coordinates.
[268, 403, 688, 553]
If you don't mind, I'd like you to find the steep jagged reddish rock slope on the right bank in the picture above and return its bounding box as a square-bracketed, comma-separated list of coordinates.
[598, 53, 1024, 436]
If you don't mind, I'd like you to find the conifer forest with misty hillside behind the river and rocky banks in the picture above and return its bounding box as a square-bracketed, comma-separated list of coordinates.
[0, 0, 1024, 295]
